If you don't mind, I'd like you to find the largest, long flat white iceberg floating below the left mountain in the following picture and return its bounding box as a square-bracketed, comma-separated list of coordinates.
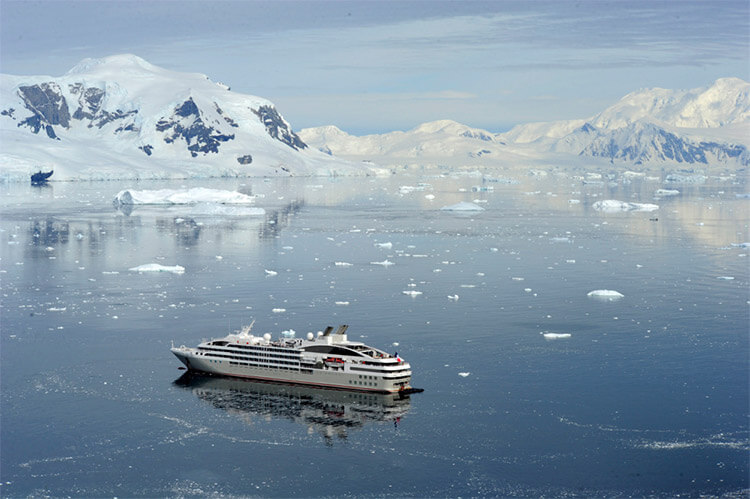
[114, 187, 255, 206]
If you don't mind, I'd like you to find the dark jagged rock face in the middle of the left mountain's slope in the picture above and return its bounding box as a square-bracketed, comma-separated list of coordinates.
[156, 97, 234, 158]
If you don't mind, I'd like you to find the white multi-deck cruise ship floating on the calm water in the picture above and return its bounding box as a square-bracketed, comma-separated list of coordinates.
[171, 324, 414, 393]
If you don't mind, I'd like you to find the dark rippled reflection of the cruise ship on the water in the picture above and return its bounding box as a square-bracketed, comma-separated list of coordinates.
[174, 372, 410, 445]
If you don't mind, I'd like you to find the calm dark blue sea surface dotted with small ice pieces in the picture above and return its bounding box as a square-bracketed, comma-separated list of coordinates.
[0, 175, 750, 497]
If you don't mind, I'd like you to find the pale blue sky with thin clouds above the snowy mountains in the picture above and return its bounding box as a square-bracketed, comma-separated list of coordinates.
[0, 0, 750, 135]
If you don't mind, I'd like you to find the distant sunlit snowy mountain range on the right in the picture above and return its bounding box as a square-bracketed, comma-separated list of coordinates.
[300, 78, 750, 169]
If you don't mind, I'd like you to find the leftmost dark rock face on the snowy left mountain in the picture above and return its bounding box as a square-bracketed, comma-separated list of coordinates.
[18, 82, 70, 138]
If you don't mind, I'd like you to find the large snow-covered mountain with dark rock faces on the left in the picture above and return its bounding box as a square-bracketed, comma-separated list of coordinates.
[0, 55, 372, 180]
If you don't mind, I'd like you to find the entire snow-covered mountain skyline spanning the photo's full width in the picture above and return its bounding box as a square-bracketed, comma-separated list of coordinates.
[0, 55, 750, 181]
